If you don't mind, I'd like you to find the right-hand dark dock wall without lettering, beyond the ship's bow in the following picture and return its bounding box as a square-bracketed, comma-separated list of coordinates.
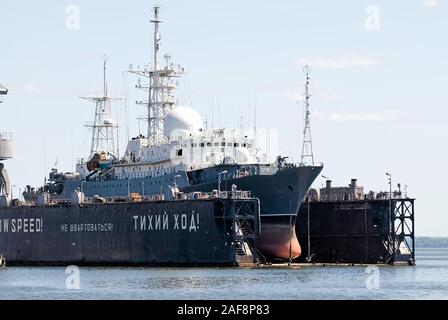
[296, 179, 415, 265]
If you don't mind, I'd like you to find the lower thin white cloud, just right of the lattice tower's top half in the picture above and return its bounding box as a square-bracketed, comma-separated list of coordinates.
[313, 109, 406, 122]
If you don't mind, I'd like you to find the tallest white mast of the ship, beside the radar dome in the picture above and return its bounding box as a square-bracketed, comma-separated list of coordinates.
[130, 5, 184, 146]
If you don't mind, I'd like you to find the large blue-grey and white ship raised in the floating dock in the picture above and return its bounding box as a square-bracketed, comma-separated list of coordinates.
[0, 6, 323, 260]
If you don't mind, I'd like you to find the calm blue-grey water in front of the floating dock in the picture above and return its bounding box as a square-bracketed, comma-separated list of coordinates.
[0, 249, 448, 300]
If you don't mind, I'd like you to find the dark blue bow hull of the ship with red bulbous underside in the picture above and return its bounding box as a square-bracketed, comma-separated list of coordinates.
[184, 167, 323, 260]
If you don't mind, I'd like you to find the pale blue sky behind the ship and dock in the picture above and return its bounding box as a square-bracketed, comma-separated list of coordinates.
[0, 0, 448, 236]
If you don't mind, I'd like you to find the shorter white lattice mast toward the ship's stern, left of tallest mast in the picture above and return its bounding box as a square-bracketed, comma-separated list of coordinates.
[81, 57, 120, 157]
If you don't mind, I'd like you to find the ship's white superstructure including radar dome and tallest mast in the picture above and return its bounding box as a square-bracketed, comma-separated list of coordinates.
[78, 6, 269, 179]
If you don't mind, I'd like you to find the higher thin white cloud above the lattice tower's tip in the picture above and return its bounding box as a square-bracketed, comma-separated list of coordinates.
[296, 54, 382, 69]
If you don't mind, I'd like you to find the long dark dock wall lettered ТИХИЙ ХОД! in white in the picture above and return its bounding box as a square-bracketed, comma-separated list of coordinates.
[0, 192, 260, 266]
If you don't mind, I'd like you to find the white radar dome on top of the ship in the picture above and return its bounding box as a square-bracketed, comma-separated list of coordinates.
[164, 107, 203, 137]
